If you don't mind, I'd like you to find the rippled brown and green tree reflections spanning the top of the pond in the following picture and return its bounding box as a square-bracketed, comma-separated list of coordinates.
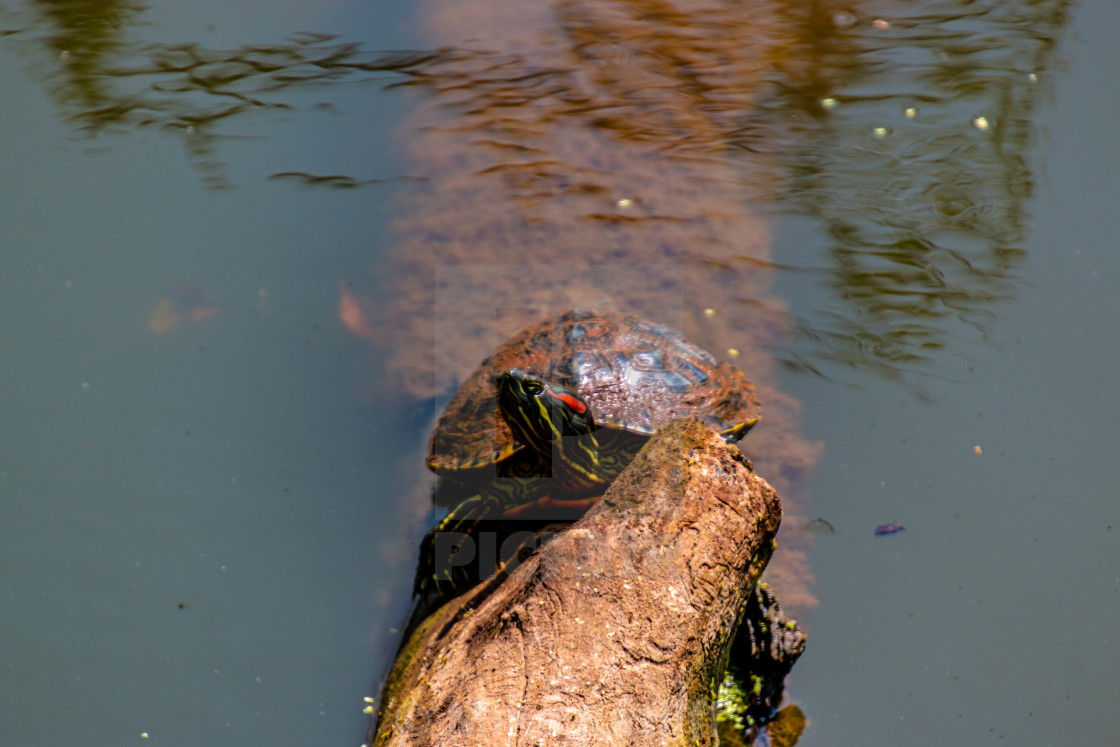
[6, 0, 1070, 391]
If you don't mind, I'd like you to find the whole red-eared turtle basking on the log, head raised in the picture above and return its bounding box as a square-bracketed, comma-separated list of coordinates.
[414, 310, 758, 618]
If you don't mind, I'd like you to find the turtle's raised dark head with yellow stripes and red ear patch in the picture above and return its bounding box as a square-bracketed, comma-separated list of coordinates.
[497, 368, 596, 455]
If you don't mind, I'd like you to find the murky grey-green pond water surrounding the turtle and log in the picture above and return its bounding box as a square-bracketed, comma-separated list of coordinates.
[0, 0, 1120, 746]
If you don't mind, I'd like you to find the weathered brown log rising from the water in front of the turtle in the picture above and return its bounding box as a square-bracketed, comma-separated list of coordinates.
[372, 420, 781, 747]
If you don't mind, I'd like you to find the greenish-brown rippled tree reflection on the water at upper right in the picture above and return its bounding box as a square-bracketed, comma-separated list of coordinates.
[731, 0, 1071, 385]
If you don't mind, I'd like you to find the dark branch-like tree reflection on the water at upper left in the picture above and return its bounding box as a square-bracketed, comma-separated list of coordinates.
[8, 0, 454, 188]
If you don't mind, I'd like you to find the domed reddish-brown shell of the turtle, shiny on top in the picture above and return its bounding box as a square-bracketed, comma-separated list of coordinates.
[428, 310, 759, 475]
